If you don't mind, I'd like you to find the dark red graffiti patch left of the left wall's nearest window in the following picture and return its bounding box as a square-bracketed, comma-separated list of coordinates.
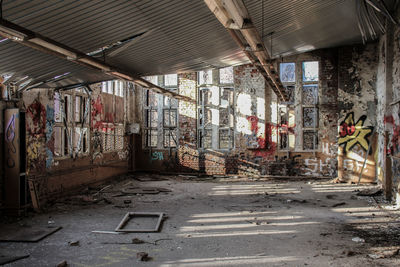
[26, 100, 46, 135]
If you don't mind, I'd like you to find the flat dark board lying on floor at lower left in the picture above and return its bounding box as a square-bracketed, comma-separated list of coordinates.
[0, 226, 62, 242]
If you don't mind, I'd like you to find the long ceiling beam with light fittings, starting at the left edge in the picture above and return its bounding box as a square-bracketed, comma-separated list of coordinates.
[0, 19, 195, 102]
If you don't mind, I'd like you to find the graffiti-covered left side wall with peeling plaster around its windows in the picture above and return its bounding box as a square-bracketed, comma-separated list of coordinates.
[19, 84, 134, 202]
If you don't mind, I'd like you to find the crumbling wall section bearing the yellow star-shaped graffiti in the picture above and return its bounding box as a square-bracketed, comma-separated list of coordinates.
[338, 43, 378, 182]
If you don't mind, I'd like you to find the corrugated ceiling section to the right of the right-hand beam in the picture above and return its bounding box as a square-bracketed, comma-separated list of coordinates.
[244, 0, 389, 57]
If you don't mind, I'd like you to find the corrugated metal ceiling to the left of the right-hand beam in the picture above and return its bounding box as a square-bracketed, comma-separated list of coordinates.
[0, 0, 248, 88]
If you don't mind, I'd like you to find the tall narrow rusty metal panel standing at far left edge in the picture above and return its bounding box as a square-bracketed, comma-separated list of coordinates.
[4, 108, 20, 208]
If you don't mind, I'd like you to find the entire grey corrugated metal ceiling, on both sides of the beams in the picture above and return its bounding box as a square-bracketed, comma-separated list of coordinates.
[0, 0, 390, 86]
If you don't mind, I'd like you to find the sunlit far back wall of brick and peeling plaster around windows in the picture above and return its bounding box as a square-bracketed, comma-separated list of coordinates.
[137, 60, 338, 176]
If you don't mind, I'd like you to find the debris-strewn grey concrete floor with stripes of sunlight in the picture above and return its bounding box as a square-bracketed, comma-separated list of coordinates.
[0, 177, 400, 267]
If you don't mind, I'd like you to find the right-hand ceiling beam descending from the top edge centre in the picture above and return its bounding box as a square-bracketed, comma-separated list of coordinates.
[204, 0, 288, 101]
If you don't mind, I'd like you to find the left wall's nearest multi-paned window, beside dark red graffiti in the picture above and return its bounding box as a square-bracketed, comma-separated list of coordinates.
[54, 88, 90, 157]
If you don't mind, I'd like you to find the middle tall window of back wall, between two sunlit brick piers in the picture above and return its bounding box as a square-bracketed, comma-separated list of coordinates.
[197, 67, 234, 149]
